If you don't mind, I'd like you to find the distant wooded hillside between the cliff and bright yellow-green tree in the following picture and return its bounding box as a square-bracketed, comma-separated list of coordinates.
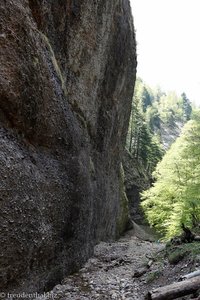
[127, 78, 191, 173]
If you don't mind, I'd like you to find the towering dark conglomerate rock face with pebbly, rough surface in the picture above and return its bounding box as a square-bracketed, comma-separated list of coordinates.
[0, 0, 136, 292]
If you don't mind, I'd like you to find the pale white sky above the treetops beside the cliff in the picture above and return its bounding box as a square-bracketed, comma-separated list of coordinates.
[130, 0, 200, 106]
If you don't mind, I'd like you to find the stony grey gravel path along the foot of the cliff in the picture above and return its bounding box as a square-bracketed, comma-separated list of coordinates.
[41, 233, 163, 300]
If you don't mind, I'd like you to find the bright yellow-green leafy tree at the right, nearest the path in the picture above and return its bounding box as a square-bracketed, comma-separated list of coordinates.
[142, 117, 200, 239]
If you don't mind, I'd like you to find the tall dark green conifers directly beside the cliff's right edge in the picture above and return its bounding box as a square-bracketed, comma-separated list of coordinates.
[127, 78, 163, 173]
